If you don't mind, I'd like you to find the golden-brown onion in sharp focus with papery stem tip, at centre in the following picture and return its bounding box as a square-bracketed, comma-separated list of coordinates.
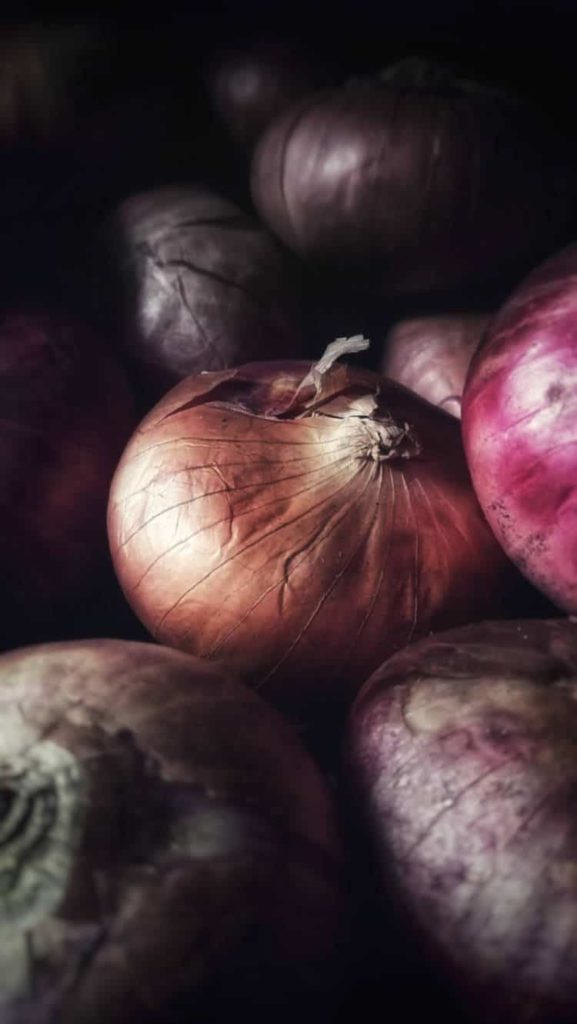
[109, 341, 514, 713]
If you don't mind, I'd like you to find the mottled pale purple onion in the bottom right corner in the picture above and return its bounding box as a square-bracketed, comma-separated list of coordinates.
[346, 620, 577, 1024]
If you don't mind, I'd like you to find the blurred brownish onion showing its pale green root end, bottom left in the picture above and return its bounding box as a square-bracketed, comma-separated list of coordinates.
[0, 640, 340, 1024]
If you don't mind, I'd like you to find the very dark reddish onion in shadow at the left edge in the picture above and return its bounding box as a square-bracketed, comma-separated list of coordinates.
[0, 310, 135, 646]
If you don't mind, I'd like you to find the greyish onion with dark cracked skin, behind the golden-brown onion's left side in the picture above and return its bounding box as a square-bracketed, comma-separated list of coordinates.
[101, 185, 301, 408]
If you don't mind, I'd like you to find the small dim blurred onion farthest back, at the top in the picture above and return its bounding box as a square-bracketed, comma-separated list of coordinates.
[205, 41, 317, 151]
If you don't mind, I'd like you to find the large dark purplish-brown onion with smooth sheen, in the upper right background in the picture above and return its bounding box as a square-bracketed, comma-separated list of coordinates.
[251, 82, 570, 295]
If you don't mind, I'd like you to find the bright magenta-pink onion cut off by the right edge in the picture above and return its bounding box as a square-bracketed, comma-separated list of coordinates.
[462, 246, 577, 612]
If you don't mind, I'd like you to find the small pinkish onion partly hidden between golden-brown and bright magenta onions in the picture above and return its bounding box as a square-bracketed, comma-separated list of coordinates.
[380, 313, 491, 419]
